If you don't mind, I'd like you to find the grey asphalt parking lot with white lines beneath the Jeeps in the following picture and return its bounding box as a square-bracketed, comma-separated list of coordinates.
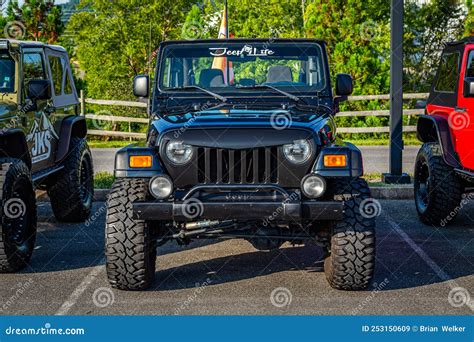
[0, 201, 474, 315]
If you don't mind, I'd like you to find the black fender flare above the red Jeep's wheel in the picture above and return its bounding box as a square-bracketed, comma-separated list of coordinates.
[416, 115, 461, 168]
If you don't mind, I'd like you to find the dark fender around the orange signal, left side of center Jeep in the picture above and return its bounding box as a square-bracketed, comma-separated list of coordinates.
[114, 145, 164, 178]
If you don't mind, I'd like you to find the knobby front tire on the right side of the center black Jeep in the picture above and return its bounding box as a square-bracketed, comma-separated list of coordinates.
[324, 178, 381, 290]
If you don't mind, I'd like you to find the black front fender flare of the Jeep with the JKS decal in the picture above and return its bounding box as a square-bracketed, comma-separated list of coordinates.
[0, 128, 32, 170]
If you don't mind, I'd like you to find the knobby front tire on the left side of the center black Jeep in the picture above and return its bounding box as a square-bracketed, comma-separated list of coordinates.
[105, 179, 156, 291]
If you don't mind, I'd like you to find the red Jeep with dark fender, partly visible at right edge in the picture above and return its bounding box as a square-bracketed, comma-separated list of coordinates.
[414, 37, 474, 226]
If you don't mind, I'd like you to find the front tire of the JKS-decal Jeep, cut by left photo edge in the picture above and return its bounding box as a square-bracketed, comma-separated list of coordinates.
[0, 158, 36, 273]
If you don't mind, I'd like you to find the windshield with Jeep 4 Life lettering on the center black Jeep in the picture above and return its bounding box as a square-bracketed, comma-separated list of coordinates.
[159, 42, 327, 93]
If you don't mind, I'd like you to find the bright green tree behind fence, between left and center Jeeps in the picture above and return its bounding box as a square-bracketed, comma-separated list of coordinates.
[68, 0, 192, 99]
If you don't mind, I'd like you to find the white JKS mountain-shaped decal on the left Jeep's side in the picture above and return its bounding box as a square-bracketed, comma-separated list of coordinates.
[26, 113, 59, 163]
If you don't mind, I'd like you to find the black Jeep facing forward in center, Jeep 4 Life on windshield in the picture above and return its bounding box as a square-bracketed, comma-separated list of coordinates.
[106, 39, 378, 290]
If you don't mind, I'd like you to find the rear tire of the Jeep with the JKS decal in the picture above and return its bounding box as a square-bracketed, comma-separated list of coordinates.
[48, 137, 94, 222]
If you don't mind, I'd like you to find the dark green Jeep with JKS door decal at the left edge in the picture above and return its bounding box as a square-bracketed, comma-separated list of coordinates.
[0, 40, 93, 273]
